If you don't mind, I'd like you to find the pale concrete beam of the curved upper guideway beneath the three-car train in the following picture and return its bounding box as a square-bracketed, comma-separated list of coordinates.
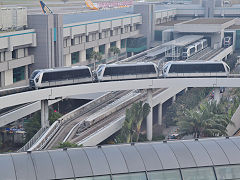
[0, 75, 240, 109]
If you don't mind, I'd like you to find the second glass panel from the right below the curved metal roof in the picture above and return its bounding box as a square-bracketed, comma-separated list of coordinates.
[181, 167, 216, 180]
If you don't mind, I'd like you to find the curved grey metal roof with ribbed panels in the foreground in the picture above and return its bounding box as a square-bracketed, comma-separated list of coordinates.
[0, 137, 240, 180]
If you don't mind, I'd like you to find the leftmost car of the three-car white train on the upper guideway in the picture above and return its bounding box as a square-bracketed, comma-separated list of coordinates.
[29, 66, 93, 89]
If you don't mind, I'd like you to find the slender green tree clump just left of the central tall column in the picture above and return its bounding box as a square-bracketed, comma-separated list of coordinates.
[116, 101, 150, 143]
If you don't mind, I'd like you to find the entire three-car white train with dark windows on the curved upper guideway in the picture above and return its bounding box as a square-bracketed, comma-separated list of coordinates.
[29, 61, 230, 89]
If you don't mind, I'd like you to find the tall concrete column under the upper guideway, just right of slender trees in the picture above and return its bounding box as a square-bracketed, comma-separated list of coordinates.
[147, 89, 153, 141]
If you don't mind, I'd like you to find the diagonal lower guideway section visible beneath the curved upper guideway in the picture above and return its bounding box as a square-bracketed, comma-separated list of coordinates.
[30, 88, 184, 150]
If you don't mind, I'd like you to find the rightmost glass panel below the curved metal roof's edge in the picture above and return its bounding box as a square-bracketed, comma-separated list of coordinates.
[215, 165, 240, 180]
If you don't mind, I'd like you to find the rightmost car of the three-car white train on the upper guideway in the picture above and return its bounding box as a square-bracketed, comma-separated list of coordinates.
[162, 61, 230, 78]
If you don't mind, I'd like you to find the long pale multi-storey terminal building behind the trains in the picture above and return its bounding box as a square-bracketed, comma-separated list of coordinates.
[0, 0, 240, 89]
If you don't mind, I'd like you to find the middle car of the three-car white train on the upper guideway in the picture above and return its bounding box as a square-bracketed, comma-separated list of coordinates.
[97, 62, 159, 81]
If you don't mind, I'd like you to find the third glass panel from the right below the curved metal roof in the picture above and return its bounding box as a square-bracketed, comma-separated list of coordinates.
[148, 170, 181, 180]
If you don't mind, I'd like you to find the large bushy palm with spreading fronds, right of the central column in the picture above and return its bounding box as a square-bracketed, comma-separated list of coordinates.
[177, 103, 231, 138]
